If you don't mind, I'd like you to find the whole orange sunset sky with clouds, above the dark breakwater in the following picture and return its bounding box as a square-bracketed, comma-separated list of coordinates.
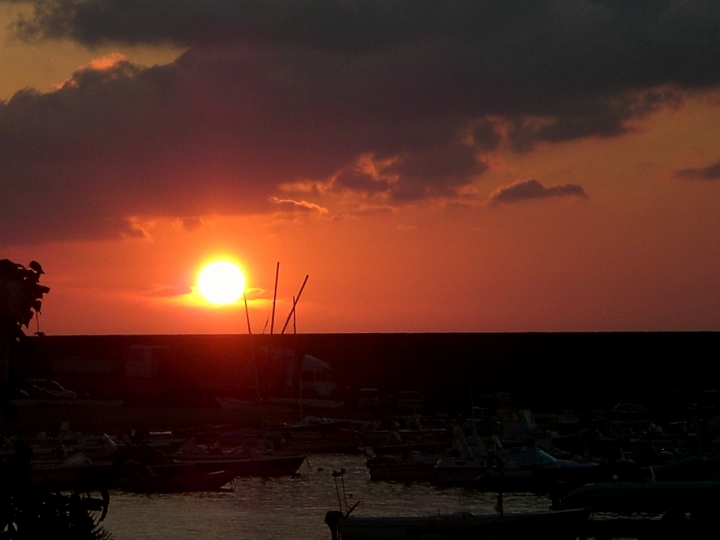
[0, 0, 720, 334]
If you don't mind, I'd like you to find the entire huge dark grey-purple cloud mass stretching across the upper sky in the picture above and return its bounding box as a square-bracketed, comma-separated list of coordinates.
[0, 0, 720, 242]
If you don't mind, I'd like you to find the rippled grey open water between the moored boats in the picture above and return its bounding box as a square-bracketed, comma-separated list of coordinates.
[104, 455, 550, 540]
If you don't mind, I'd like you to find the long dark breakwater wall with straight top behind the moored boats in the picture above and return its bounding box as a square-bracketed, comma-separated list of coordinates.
[7, 332, 720, 416]
